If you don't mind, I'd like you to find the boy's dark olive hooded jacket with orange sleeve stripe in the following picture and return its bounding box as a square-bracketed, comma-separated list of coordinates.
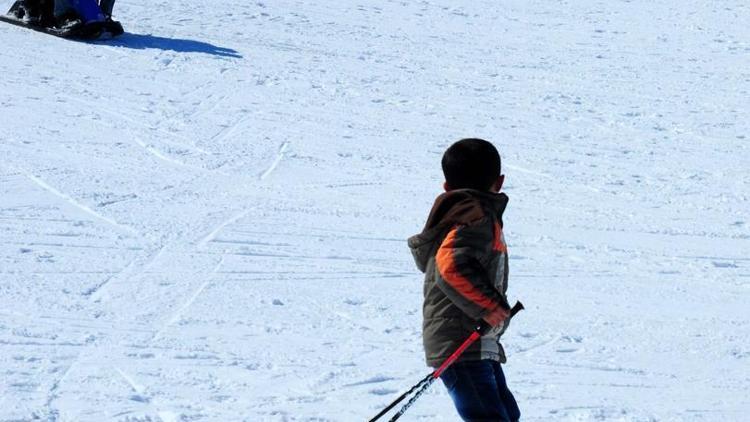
[409, 189, 510, 367]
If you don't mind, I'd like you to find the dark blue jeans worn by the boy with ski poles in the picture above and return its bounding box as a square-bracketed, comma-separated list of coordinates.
[440, 360, 521, 422]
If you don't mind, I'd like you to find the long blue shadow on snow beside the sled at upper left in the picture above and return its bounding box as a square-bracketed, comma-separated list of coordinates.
[107, 32, 242, 59]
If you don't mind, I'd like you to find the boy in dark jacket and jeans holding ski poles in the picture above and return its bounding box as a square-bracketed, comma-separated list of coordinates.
[409, 139, 520, 422]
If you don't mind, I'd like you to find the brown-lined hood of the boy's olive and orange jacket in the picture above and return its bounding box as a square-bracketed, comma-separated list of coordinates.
[409, 189, 508, 272]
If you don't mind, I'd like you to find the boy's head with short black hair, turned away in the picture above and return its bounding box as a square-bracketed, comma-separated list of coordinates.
[442, 138, 505, 192]
